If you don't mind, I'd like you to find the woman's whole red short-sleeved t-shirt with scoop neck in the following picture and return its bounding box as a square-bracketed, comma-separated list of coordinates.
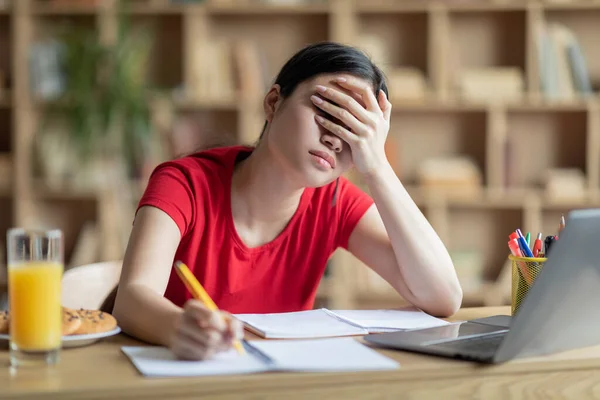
[138, 146, 373, 313]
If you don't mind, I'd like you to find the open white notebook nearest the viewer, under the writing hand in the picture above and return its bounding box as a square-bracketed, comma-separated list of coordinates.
[122, 338, 399, 377]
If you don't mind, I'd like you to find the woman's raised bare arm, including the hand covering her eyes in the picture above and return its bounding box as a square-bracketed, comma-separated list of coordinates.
[315, 76, 462, 316]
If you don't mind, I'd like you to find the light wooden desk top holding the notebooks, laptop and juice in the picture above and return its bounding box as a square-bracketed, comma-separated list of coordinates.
[0, 307, 600, 400]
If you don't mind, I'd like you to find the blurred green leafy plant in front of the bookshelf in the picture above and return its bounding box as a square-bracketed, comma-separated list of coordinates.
[55, 3, 153, 177]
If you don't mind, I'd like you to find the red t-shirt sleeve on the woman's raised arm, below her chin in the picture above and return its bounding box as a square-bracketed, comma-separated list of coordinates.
[336, 177, 374, 250]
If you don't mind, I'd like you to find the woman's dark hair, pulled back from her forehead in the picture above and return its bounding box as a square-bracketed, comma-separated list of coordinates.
[259, 42, 389, 140]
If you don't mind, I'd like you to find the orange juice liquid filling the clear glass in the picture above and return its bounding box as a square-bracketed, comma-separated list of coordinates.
[8, 261, 63, 351]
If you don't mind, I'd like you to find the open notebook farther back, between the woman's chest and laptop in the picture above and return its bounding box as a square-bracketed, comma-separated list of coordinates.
[235, 308, 448, 339]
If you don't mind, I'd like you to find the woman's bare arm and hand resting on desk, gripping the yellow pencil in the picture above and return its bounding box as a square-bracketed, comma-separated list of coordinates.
[113, 206, 243, 359]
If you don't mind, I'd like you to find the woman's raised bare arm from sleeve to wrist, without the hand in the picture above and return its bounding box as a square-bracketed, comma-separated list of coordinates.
[348, 173, 462, 317]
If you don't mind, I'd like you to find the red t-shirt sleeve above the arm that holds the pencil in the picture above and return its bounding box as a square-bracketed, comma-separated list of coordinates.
[136, 164, 196, 237]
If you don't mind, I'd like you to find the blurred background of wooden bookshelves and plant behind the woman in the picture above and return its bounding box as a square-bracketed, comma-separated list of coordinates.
[0, 0, 600, 308]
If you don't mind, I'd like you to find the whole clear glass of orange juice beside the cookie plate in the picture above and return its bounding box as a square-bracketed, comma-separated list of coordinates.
[7, 228, 64, 366]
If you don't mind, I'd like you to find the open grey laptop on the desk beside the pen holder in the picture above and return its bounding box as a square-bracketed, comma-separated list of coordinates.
[364, 209, 600, 364]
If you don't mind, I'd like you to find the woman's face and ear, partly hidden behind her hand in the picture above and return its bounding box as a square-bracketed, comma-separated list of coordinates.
[264, 74, 368, 187]
